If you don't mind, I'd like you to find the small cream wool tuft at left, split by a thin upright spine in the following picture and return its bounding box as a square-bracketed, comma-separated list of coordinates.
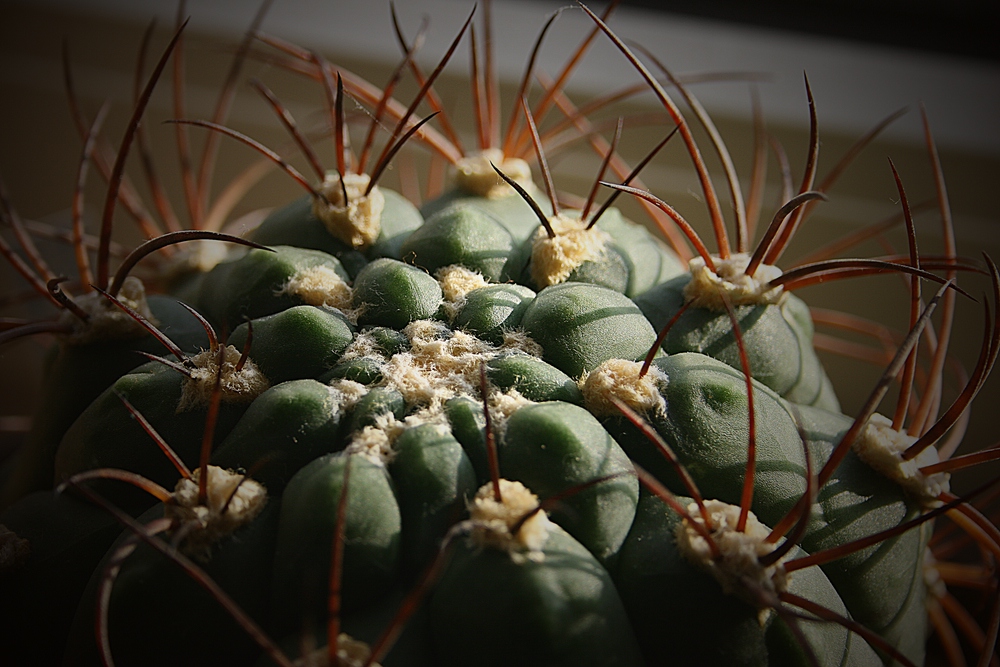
[177, 345, 270, 412]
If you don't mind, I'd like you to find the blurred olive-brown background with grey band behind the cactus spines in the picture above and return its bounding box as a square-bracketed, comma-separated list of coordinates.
[0, 0, 1000, 490]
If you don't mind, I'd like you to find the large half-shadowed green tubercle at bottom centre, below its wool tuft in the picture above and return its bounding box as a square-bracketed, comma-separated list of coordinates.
[430, 527, 642, 667]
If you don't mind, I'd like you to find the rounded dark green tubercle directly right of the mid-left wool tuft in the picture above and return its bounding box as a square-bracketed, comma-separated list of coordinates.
[226, 306, 354, 384]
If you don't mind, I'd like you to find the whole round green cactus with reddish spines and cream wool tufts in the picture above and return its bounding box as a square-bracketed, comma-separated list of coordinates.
[0, 5, 1000, 665]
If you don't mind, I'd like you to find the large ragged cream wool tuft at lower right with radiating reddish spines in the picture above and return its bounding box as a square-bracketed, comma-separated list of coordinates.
[674, 500, 790, 624]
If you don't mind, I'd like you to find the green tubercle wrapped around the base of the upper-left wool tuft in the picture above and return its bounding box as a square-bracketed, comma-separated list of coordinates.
[250, 188, 424, 277]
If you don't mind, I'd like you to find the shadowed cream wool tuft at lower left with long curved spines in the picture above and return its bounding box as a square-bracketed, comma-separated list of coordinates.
[163, 465, 267, 562]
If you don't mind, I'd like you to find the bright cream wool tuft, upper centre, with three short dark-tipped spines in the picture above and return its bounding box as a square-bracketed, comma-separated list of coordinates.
[531, 215, 611, 287]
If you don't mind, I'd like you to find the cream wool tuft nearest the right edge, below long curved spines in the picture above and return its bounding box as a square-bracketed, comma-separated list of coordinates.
[853, 413, 951, 507]
